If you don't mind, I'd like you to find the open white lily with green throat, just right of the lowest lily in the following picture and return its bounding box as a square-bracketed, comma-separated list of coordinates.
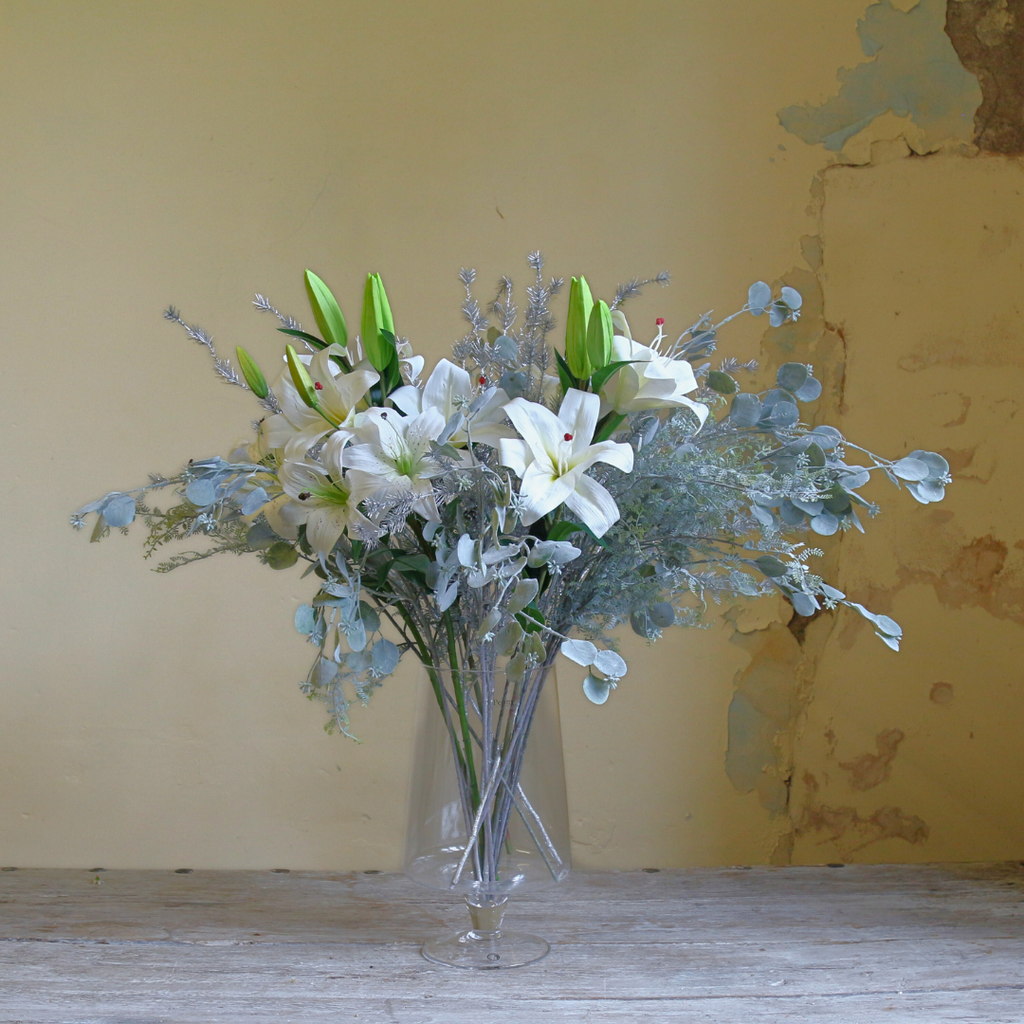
[343, 407, 444, 520]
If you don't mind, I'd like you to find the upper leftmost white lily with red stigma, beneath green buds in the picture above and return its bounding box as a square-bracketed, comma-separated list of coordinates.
[262, 345, 380, 460]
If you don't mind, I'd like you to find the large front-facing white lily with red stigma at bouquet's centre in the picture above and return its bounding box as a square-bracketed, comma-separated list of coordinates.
[499, 388, 633, 537]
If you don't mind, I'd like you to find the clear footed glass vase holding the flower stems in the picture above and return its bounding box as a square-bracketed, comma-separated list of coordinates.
[404, 653, 569, 969]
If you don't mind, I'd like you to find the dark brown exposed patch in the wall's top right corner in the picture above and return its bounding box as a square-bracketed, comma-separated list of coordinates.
[946, 0, 1024, 156]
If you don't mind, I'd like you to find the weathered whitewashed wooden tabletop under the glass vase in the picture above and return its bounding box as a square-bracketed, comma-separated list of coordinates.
[0, 861, 1024, 1024]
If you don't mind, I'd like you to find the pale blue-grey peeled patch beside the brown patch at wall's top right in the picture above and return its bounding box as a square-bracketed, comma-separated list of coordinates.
[778, 0, 982, 153]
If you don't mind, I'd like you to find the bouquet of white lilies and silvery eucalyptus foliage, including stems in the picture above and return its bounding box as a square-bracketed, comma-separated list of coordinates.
[73, 253, 949, 913]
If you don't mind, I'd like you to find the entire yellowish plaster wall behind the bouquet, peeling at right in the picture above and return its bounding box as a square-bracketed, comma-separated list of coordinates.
[0, 0, 1024, 868]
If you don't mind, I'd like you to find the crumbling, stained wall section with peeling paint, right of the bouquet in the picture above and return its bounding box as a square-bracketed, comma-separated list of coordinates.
[727, 0, 1024, 863]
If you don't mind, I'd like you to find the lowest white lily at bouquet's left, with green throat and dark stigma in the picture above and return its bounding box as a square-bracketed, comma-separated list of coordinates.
[276, 434, 377, 555]
